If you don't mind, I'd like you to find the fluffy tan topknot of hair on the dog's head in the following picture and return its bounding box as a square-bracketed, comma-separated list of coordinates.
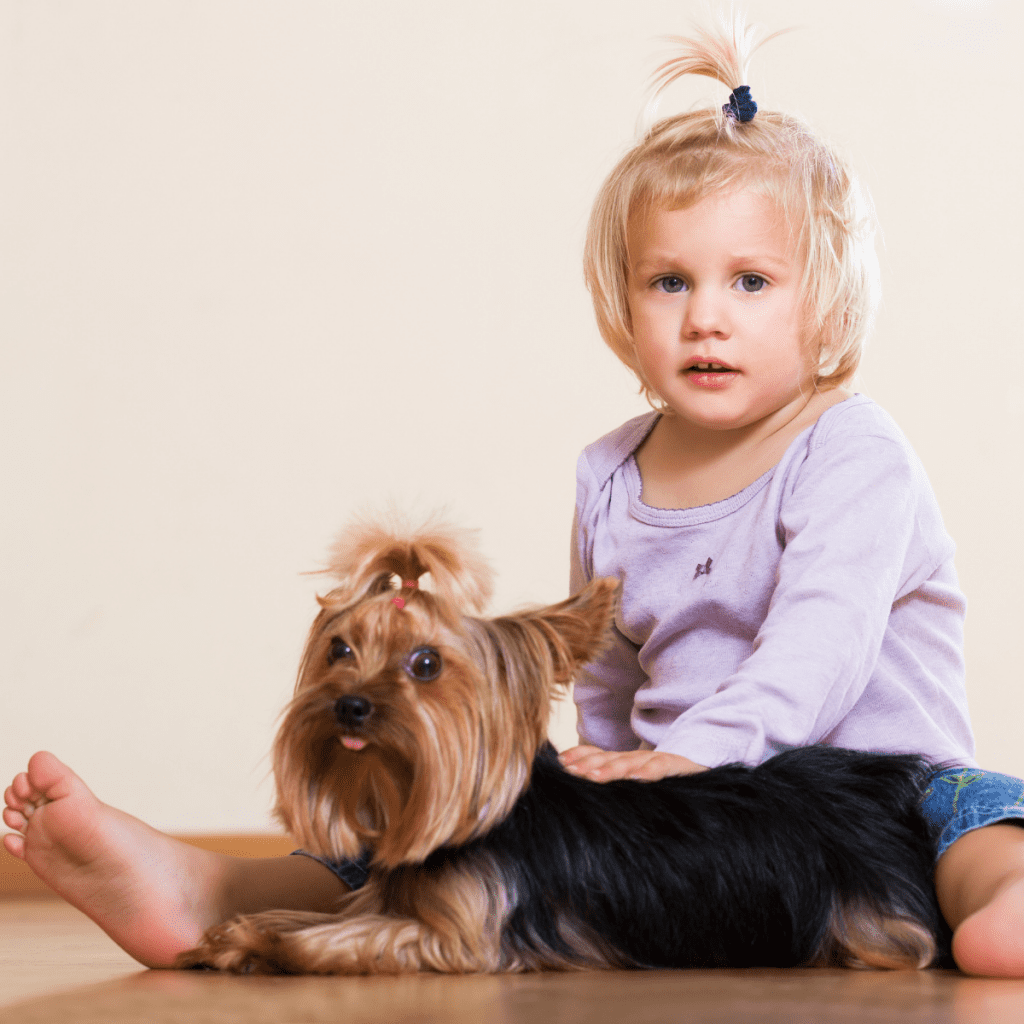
[326, 515, 494, 613]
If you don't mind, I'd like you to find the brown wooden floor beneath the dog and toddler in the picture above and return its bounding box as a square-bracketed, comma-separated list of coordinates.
[6, 900, 1024, 1024]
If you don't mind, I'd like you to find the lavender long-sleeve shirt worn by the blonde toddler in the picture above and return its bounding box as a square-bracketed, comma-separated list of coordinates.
[571, 395, 975, 766]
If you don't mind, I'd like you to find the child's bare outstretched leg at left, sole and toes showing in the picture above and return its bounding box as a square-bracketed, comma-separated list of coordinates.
[3, 753, 347, 967]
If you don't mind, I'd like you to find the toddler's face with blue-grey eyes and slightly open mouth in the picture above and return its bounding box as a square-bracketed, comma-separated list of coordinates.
[629, 191, 814, 430]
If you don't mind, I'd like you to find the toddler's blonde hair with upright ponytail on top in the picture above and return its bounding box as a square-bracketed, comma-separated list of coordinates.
[584, 16, 880, 399]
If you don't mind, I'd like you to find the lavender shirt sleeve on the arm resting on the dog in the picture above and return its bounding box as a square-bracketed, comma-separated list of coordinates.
[656, 425, 937, 766]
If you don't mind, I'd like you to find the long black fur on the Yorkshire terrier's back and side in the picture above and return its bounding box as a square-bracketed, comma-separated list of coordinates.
[424, 745, 948, 968]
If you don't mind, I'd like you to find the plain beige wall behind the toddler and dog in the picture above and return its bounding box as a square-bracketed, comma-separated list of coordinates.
[0, 0, 1024, 830]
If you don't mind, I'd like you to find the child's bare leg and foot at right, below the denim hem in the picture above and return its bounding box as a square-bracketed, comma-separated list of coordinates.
[935, 824, 1024, 978]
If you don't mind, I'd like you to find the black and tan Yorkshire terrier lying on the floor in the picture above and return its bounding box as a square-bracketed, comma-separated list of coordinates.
[178, 527, 948, 974]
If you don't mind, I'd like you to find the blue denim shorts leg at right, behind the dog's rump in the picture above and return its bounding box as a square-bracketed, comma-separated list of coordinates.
[921, 768, 1024, 858]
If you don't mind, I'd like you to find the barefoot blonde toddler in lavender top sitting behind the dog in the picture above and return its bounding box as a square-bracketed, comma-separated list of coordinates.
[4, 14, 1024, 977]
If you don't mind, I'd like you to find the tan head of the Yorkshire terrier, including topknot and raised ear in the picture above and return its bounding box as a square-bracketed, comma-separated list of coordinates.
[273, 525, 616, 867]
